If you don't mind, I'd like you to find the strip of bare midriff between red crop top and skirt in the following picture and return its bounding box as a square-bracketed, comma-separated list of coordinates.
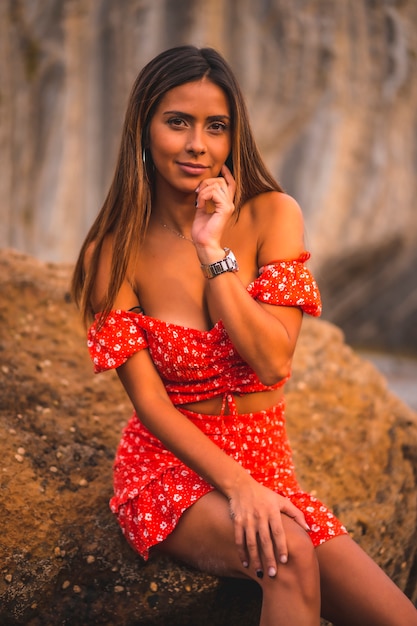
[177, 387, 283, 415]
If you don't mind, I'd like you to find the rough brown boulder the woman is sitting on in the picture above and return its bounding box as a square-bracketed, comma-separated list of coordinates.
[0, 250, 417, 626]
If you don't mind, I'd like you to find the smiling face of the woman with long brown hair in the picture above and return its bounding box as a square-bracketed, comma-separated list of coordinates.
[149, 78, 232, 194]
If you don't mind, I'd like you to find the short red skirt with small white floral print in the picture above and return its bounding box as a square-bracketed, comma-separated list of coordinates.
[110, 395, 347, 559]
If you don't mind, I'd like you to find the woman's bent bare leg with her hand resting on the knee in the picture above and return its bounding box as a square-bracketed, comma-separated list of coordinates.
[159, 491, 320, 626]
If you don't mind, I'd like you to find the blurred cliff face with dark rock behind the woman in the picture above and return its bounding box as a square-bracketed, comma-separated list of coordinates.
[0, 0, 417, 351]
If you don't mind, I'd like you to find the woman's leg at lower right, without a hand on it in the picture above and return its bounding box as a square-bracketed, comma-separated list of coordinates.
[316, 536, 417, 626]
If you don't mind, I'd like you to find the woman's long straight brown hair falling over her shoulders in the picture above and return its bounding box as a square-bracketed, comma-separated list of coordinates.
[72, 46, 282, 323]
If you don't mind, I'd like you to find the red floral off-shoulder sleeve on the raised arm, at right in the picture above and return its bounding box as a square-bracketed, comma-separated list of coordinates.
[248, 252, 322, 317]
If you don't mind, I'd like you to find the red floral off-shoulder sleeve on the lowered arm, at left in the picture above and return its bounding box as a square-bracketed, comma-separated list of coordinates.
[87, 310, 148, 374]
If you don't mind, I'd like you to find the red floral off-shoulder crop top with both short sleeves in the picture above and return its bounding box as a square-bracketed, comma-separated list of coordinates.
[88, 253, 321, 405]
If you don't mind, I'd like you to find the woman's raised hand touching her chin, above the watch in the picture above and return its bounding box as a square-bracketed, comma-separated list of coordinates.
[191, 165, 236, 255]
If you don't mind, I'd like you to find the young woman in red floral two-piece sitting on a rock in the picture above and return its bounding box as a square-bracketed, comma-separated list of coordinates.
[73, 46, 417, 626]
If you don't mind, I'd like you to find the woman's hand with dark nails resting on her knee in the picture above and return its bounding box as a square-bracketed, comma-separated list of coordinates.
[229, 479, 310, 577]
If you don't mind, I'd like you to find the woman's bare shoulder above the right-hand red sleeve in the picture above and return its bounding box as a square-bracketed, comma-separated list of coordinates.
[247, 191, 304, 265]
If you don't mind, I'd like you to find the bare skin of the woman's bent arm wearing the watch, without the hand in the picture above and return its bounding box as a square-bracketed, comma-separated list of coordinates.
[196, 178, 304, 385]
